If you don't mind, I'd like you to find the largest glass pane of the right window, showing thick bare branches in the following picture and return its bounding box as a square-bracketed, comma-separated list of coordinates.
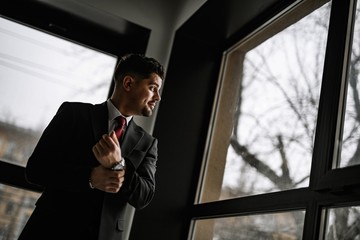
[220, 3, 330, 199]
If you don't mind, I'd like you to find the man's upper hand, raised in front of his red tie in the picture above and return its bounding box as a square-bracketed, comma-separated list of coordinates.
[92, 131, 121, 168]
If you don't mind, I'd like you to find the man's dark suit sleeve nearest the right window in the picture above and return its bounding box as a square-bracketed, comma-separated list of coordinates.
[124, 138, 158, 209]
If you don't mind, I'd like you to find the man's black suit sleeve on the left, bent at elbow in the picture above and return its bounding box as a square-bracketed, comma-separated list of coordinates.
[25, 103, 91, 191]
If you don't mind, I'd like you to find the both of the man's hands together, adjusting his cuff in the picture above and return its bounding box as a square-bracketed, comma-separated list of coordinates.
[90, 131, 125, 193]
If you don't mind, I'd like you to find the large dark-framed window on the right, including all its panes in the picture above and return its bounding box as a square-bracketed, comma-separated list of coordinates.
[190, 0, 360, 240]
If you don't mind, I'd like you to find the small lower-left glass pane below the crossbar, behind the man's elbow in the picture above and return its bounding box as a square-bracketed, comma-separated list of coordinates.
[0, 184, 40, 240]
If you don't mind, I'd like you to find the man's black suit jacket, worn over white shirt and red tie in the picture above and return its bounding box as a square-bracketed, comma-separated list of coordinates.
[19, 102, 157, 240]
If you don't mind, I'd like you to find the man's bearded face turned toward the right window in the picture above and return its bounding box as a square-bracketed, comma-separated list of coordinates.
[130, 73, 162, 117]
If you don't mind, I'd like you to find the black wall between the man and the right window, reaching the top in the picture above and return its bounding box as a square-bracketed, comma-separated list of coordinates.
[130, 0, 292, 240]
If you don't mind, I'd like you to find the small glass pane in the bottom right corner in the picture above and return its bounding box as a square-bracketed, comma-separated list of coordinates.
[323, 207, 360, 240]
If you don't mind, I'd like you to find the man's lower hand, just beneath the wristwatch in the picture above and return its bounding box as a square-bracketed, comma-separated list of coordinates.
[90, 165, 125, 193]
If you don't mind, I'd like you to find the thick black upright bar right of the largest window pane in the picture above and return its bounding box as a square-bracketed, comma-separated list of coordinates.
[310, 0, 353, 189]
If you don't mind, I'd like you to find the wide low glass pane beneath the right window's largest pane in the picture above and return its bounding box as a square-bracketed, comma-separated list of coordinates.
[192, 211, 305, 240]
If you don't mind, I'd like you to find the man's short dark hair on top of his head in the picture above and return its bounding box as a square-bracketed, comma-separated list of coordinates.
[114, 53, 164, 82]
